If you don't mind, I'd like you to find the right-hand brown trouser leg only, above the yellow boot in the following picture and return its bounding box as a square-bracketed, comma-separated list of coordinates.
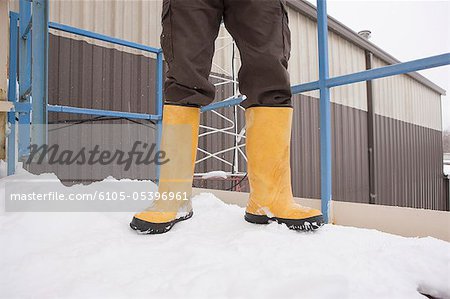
[224, 0, 292, 108]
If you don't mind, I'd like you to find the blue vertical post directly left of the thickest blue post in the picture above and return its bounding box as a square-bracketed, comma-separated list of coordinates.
[17, 0, 32, 160]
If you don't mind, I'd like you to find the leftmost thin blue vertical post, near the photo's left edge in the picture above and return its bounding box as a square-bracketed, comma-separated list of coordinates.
[7, 14, 19, 175]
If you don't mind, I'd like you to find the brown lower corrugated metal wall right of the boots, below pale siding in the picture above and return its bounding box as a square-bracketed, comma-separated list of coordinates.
[291, 96, 448, 210]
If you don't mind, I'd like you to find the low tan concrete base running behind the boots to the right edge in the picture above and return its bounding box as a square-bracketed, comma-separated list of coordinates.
[193, 189, 450, 242]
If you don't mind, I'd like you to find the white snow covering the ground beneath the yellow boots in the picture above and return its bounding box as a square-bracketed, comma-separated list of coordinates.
[0, 164, 450, 298]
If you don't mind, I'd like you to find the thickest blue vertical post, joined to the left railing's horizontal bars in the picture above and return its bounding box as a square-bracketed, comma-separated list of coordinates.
[31, 0, 48, 145]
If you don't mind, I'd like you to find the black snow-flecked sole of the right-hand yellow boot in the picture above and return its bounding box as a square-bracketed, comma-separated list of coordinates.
[245, 212, 324, 231]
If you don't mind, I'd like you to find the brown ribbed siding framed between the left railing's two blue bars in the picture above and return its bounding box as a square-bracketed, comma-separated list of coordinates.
[49, 35, 156, 118]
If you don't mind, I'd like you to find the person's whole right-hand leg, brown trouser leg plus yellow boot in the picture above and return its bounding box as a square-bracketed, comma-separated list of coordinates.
[225, 0, 323, 230]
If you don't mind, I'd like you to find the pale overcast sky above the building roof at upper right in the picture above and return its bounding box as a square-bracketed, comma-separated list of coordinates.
[307, 0, 450, 130]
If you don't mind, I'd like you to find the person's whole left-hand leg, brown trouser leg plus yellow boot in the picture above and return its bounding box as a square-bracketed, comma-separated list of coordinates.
[130, 0, 223, 234]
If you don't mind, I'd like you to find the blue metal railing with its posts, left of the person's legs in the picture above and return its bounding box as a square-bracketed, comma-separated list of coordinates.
[7, 9, 163, 177]
